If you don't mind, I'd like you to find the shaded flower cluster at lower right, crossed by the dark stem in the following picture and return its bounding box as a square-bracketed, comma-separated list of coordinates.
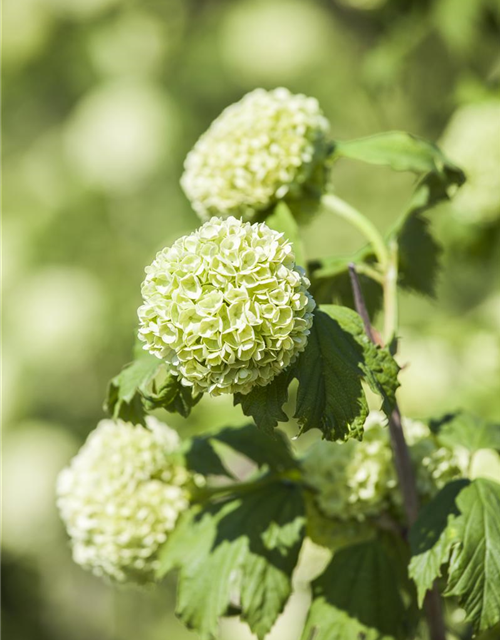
[302, 412, 467, 521]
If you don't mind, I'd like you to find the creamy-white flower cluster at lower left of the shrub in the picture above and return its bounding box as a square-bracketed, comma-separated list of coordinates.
[57, 417, 190, 584]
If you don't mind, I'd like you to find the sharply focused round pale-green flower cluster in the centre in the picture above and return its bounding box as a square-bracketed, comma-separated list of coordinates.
[138, 217, 315, 395]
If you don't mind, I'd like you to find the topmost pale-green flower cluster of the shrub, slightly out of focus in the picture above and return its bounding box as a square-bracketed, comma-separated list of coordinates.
[181, 88, 331, 220]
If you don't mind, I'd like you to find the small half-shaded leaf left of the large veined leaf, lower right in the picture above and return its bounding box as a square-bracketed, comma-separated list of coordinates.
[409, 480, 469, 607]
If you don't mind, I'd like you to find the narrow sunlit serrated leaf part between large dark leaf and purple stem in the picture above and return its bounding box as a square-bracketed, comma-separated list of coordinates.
[321, 305, 399, 416]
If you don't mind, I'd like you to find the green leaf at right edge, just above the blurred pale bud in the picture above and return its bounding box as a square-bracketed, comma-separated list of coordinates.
[430, 411, 500, 453]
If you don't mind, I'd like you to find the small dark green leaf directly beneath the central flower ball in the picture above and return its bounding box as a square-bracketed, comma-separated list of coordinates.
[234, 365, 294, 434]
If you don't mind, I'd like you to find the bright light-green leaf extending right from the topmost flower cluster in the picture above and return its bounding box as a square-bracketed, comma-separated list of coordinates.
[334, 131, 461, 179]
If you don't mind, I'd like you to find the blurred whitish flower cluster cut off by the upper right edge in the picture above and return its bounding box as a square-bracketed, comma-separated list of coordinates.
[442, 100, 500, 223]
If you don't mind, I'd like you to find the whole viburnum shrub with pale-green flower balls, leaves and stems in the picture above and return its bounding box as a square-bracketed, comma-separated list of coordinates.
[57, 89, 500, 640]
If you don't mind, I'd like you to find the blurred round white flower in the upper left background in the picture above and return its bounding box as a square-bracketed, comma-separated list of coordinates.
[66, 80, 176, 193]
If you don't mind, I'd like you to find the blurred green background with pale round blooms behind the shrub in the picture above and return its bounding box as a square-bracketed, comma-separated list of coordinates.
[2, 0, 500, 640]
